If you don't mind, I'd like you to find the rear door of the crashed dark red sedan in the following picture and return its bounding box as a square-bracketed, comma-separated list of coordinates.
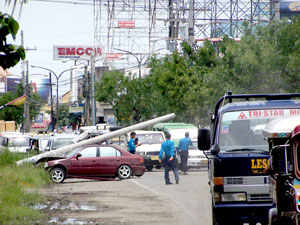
[99, 146, 122, 176]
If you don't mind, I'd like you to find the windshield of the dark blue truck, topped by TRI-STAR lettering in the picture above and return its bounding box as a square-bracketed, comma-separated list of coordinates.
[218, 109, 295, 152]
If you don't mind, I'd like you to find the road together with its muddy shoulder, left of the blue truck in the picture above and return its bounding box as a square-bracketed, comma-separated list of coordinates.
[41, 169, 211, 225]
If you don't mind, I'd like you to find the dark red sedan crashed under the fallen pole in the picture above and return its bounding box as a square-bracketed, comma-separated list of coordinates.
[44, 145, 145, 183]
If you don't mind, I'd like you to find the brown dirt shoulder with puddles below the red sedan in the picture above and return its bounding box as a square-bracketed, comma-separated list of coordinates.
[37, 179, 178, 225]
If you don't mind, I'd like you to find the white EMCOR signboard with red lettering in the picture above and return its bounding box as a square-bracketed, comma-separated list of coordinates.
[53, 46, 102, 60]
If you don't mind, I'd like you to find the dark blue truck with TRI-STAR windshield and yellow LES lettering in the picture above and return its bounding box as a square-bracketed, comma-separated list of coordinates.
[198, 93, 300, 225]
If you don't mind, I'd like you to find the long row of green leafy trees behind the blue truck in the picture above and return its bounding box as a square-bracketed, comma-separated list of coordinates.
[96, 18, 300, 126]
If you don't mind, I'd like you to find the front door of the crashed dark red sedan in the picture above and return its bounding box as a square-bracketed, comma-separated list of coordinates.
[69, 146, 100, 176]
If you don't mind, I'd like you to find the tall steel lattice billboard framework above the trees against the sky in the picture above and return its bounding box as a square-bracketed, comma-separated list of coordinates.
[93, 0, 275, 68]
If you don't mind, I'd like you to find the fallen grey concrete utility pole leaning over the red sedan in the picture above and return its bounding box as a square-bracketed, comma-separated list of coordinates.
[17, 113, 175, 165]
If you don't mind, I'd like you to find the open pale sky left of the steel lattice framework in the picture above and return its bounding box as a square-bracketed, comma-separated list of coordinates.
[0, 0, 94, 96]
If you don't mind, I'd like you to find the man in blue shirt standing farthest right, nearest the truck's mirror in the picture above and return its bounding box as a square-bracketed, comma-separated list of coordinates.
[177, 132, 193, 175]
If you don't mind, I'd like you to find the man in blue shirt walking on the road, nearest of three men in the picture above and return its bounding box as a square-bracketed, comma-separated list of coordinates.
[159, 133, 179, 185]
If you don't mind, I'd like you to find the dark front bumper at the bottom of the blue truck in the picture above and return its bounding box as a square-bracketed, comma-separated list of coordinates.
[213, 203, 273, 225]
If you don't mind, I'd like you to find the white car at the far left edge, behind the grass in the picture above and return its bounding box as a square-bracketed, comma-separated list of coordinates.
[0, 132, 30, 153]
